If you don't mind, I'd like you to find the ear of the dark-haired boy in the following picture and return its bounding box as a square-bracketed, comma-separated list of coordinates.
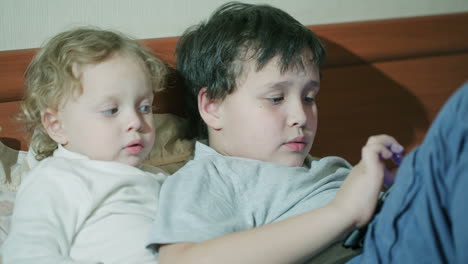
[197, 88, 222, 130]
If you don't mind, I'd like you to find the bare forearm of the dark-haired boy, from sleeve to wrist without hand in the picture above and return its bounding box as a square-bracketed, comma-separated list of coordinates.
[159, 203, 354, 264]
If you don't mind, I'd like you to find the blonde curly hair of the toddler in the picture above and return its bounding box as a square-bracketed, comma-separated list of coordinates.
[18, 27, 167, 160]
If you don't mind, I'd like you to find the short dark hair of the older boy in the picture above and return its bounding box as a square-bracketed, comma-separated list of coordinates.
[176, 2, 325, 138]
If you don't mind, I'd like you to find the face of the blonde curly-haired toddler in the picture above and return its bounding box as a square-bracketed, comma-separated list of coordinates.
[52, 54, 155, 166]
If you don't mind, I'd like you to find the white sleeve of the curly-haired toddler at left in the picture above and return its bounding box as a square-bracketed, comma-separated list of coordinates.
[3, 161, 98, 264]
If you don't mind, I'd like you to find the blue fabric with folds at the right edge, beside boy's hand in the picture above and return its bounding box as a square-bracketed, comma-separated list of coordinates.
[348, 83, 468, 264]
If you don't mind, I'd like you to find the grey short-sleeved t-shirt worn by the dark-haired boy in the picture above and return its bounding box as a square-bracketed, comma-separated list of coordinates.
[149, 142, 351, 247]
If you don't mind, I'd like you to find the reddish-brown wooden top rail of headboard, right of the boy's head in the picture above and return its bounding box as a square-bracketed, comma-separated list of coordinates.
[309, 13, 468, 67]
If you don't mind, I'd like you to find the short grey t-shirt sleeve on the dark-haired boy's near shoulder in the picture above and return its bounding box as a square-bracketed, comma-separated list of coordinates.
[150, 159, 243, 249]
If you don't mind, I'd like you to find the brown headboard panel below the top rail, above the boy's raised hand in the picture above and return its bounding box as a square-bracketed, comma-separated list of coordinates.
[311, 52, 468, 163]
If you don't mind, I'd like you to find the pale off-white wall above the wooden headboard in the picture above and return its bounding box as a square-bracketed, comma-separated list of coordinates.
[0, 0, 468, 50]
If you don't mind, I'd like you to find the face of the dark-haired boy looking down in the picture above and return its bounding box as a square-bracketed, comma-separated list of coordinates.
[210, 55, 320, 166]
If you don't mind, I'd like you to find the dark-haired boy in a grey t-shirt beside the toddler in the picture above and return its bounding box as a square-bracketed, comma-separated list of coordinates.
[147, 2, 468, 264]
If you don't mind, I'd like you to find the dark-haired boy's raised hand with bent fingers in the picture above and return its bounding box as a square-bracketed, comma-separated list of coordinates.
[333, 135, 403, 228]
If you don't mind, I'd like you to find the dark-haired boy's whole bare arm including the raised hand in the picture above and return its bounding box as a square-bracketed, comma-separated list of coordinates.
[159, 135, 402, 264]
